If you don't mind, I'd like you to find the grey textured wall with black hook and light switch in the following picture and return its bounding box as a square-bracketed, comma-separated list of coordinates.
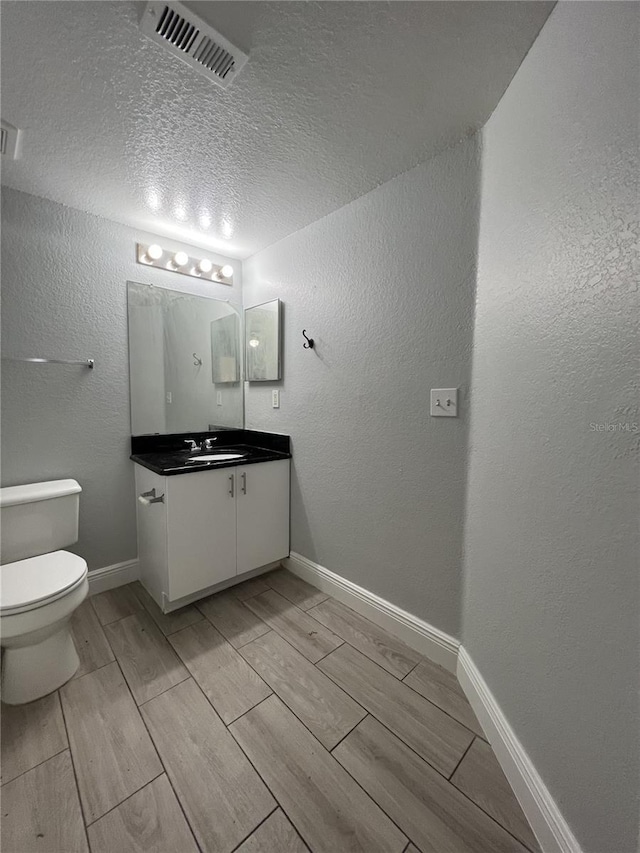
[243, 140, 479, 634]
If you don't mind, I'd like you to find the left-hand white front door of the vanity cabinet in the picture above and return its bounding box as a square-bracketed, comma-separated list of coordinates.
[166, 468, 238, 601]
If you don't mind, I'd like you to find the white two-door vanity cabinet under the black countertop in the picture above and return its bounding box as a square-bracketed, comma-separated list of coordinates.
[136, 459, 289, 610]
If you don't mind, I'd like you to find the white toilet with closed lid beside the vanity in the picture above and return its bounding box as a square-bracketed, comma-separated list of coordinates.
[0, 480, 89, 705]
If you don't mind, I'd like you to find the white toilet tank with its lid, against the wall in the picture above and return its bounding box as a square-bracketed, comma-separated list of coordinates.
[0, 480, 82, 563]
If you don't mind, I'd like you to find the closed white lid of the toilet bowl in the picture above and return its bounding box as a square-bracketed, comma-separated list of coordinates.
[0, 551, 87, 614]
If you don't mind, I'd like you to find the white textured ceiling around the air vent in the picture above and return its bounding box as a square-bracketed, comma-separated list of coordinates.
[1, 0, 553, 257]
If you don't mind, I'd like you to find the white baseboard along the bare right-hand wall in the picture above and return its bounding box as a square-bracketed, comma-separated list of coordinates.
[457, 646, 582, 853]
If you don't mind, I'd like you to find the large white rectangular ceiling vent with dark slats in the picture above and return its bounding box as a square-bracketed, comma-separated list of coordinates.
[140, 2, 249, 89]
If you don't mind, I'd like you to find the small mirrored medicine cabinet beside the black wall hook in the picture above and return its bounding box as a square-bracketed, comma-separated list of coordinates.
[244, 299, 282, 382]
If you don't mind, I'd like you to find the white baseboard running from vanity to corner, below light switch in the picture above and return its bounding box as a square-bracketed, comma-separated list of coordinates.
[282, 552, 459, 672]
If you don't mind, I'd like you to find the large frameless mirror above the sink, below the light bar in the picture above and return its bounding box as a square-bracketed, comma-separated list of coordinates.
[127, 281, 244, 435]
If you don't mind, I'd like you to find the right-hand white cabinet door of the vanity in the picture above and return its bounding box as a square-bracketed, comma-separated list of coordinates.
[235, 459, 289, 575]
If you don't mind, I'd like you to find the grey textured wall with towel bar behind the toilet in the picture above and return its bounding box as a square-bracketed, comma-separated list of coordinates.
[2, 188, 241, 569]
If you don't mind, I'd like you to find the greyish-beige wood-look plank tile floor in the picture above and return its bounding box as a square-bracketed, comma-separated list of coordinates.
[0, 569, 539, 853]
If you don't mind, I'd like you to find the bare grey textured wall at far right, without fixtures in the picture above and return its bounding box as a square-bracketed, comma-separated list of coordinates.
[463, 3, 640, 853]
